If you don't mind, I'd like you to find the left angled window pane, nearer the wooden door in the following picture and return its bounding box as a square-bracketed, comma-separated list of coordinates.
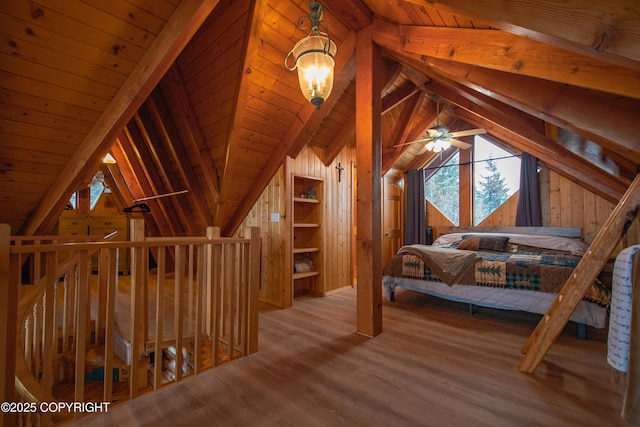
[424, 153, 460, 226]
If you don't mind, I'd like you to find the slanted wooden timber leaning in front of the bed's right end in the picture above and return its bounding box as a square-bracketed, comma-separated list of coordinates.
[518, 174, 640, 373]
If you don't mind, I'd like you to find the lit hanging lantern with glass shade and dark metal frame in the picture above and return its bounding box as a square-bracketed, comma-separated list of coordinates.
[284, 2, 337, 110]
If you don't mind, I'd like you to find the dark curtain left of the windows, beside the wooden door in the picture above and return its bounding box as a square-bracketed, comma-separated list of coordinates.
[404, 169, 427, 245]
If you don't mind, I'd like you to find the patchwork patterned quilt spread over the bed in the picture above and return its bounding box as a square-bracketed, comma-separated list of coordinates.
[383, 244, 611, 308]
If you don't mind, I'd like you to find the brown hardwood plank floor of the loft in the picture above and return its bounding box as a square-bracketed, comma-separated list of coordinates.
[69, 289, 626, 427]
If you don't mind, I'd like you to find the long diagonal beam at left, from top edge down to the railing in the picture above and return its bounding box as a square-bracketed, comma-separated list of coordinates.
[20, 0, 219, 235]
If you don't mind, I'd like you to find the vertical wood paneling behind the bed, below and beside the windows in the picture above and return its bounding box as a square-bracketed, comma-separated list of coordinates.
[427, 168, 640, 254]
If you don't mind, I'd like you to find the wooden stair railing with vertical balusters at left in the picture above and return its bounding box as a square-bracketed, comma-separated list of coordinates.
[0, 220, 260, 426]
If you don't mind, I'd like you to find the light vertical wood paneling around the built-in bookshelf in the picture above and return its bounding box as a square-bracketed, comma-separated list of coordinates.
[237, 146, 355, 307]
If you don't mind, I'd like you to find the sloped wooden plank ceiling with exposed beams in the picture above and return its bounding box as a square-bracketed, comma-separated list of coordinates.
[0, 0, 640, 235]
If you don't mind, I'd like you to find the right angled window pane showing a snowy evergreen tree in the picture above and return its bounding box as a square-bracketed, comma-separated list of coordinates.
[473, 136, 520, 225]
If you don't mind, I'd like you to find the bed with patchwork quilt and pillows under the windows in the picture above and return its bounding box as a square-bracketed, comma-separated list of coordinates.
[382, 227, 611, 338]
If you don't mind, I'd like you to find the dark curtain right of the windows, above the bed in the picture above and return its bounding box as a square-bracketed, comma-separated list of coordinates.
[516, 153, 542, 227]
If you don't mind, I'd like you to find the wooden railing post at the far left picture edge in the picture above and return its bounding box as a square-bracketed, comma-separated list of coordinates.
[0, 224, 18, 427]
